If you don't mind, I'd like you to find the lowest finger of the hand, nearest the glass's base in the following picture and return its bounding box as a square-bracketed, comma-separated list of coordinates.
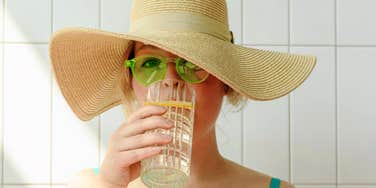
[120, 146, 163, 166]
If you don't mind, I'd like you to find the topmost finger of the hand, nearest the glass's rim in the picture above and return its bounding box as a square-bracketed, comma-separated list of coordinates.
[127, 105, 167, 123]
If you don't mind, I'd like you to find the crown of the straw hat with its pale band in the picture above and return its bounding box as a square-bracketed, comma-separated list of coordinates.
[130, 0, 231, 40]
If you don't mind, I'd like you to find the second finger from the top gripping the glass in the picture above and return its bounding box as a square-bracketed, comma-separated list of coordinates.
[119, 116, 174, 137]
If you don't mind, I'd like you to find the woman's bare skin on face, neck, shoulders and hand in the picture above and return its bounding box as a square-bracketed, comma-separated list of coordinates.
[68, 42, 293, 188]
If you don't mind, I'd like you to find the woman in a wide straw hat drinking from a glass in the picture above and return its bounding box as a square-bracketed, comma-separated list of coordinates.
[50, 0, 316, 188]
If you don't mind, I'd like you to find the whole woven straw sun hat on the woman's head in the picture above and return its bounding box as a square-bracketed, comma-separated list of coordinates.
[49, 0, 316, 121]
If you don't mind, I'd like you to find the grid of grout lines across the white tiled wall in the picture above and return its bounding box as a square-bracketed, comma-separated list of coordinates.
[1, 0, 376, 187]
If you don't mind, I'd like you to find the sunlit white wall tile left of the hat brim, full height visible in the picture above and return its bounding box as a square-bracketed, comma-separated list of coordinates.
[3, 44, 51, 183]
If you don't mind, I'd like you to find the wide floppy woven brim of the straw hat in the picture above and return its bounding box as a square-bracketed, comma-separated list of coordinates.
[49, 27, 316, 121]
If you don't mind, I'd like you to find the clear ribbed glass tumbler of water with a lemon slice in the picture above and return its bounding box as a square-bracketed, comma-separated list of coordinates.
[141, 79, 195, 188]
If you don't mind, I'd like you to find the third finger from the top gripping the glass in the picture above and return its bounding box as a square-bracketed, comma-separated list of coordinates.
[118, 133, 172, 152]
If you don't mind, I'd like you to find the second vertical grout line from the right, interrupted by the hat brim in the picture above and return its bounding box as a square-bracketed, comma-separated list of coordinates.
[287, 0, 292, 184]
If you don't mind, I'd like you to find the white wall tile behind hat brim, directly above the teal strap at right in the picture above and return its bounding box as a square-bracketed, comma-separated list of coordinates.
[243, 46, 290, 180]
